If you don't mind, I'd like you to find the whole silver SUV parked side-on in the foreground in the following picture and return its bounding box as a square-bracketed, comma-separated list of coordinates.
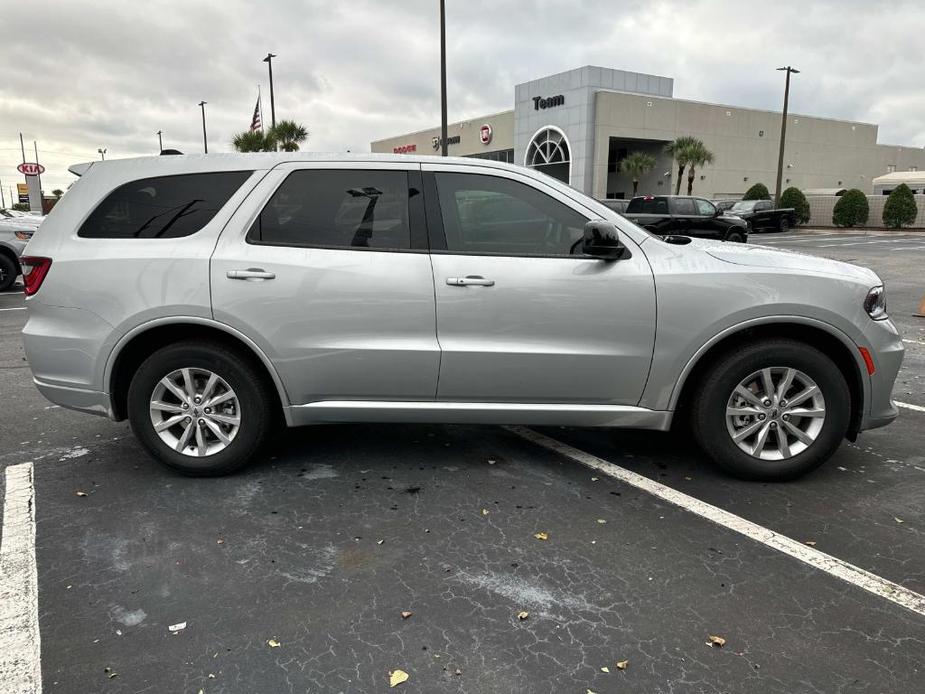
[23, 154, 903, 479]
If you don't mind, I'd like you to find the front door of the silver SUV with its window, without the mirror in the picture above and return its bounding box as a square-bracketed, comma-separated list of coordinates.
[424, 164, 655, 405]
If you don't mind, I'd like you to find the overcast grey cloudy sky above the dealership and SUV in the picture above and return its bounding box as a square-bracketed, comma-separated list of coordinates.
[0, 0, 925, 196]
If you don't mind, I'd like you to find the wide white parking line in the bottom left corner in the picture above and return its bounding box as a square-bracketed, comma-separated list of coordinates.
[0, 463, 42, 694]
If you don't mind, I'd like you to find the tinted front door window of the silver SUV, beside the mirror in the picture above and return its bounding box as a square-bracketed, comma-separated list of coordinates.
[436, 173, 588, 255]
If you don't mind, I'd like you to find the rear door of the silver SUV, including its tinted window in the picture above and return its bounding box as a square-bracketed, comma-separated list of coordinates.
[211, 162, 440, 404]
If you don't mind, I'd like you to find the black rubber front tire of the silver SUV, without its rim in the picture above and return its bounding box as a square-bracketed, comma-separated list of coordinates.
[691, 339, 851, 482]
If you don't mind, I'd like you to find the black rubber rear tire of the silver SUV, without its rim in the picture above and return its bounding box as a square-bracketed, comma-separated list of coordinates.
[128, 341, 276, 477]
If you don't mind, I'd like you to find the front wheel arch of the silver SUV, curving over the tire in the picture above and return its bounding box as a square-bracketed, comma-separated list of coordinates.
[669, 317, 870, 441]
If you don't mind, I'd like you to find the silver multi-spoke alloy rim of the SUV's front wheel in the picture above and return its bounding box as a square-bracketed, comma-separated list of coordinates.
[726, 366, 826, 461]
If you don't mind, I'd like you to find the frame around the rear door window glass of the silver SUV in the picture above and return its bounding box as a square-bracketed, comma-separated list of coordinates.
[238, 167, 428, 253]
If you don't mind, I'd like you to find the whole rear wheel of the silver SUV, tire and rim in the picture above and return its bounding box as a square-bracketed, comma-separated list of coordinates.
[128, 342, 273, 476]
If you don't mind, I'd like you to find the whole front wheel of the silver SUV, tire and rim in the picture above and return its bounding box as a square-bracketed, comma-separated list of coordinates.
[691, 340, 851, 481]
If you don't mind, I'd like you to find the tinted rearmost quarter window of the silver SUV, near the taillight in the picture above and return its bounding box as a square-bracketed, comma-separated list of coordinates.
[77, 171, 252, 239]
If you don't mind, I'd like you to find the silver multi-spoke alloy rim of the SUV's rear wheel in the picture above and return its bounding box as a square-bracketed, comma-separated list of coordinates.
[149, 368, 241, 458]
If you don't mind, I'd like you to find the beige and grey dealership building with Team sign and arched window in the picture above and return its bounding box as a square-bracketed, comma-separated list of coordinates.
[371, 66, 925, 199]
